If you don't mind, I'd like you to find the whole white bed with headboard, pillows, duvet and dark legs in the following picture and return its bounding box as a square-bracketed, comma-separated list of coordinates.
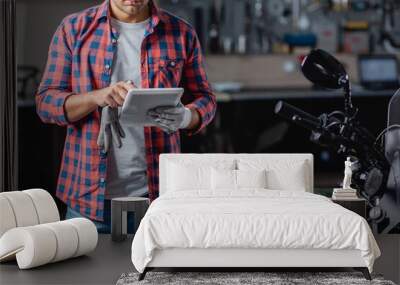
[132, 154, 380, 278]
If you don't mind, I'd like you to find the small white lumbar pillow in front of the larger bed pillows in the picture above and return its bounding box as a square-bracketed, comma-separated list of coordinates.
[211, 168, 267, 190]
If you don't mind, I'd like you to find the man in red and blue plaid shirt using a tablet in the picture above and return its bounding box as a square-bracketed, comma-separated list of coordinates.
[36, 0, 216, 232]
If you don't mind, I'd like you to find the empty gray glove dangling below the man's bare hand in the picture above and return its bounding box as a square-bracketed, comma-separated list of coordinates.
[97, 106, 125, 152]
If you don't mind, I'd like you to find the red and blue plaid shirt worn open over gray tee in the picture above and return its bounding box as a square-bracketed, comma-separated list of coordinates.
[36, 1, 216, 221]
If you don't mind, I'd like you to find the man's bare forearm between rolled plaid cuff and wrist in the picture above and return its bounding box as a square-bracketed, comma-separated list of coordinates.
[64, 91, 98, 123]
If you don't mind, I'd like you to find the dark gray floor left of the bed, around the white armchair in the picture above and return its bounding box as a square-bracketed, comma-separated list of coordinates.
[0, 235, 134, 285]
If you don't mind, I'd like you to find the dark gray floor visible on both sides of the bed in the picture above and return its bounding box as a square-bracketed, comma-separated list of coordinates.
[0, 235, 400, 285]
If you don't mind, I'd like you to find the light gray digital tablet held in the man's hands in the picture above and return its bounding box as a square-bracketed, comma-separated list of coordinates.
[120, 88, 183, 126]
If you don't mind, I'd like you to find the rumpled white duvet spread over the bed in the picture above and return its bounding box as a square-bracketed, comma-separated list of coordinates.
[132, 189, 380, 272]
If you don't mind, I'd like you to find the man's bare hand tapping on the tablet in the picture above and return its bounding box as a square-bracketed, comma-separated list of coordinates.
[91, 81, 135, 108]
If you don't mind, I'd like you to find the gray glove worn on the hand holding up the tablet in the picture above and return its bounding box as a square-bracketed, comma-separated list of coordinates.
[147, 102, 192, 134]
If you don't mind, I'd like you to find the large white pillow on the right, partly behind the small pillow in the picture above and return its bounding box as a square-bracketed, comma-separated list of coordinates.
[237, 159, 310, 191]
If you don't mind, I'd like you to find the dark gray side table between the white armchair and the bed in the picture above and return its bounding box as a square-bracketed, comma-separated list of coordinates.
[111, 197, 150, 241]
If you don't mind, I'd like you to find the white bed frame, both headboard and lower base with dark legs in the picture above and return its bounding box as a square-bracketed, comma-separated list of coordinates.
[139, 154, 371, 280]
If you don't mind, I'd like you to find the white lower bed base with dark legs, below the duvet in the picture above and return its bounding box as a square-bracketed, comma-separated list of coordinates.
[139, 248, 371, 280]
